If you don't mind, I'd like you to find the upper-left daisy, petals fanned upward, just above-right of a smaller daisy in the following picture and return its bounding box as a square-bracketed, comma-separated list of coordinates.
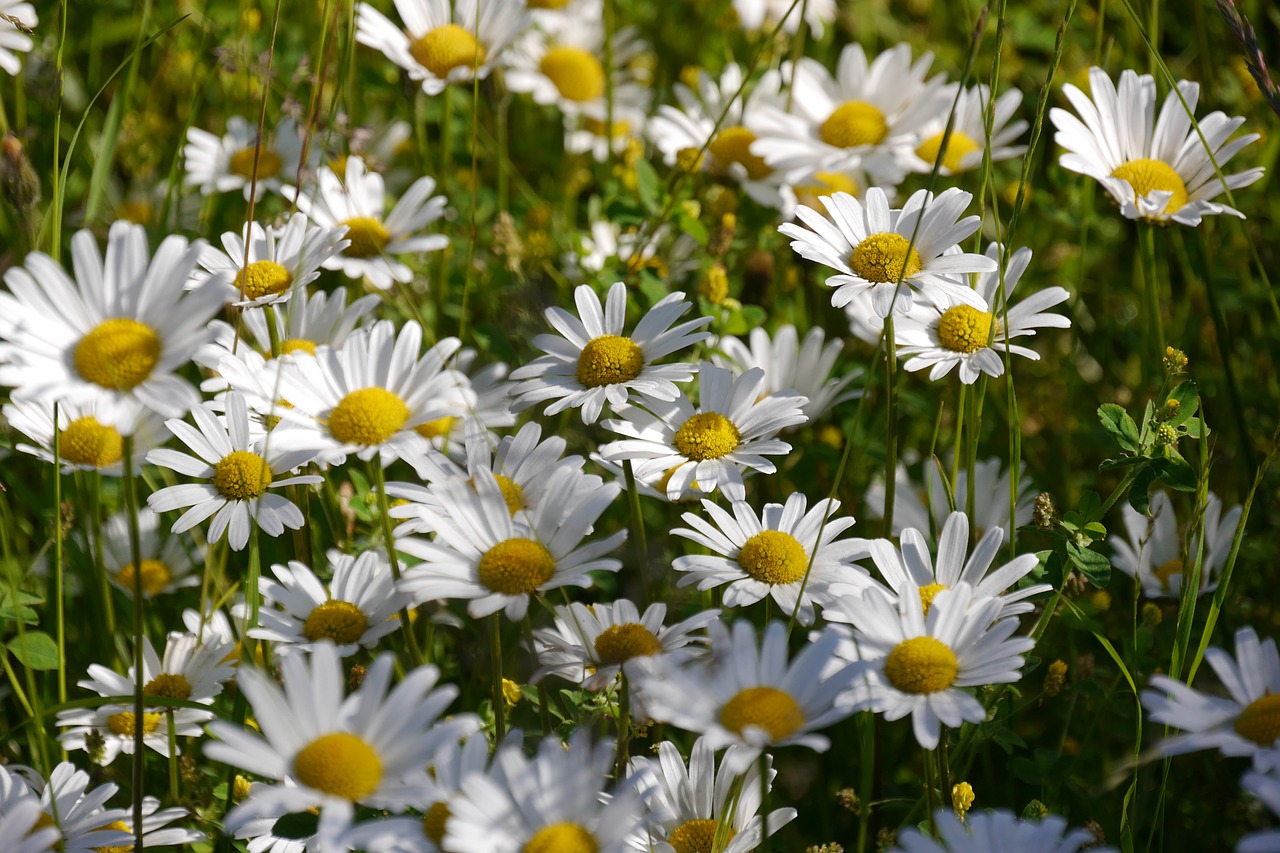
[280, 158, 449, 291]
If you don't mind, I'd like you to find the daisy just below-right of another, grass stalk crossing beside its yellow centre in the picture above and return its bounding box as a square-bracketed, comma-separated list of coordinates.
[893, 243, 1071, 386]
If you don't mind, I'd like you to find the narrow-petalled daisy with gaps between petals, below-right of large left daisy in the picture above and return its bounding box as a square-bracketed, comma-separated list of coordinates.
[147, 392, 323, 551]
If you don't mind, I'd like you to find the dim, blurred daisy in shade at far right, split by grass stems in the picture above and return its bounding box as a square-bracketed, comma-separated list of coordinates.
[1107, 492, 1244, 598]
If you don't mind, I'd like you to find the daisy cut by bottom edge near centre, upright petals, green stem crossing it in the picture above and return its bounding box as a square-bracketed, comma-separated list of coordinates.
[628, 738, 796, 853]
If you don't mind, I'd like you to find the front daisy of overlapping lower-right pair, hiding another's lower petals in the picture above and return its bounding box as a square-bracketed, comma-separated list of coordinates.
[844, 581, 1036, 749]
